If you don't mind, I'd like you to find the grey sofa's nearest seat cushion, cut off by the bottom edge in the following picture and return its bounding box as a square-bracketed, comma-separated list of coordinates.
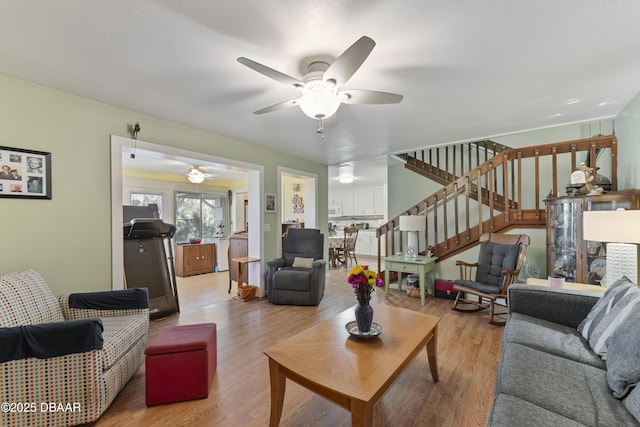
[489, 394, 582, 427]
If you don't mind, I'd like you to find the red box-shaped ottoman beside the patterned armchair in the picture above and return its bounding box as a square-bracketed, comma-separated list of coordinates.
[145, 323, 218, 406]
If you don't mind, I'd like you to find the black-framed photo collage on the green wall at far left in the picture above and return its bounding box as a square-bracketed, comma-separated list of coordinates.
[0, 146, 51, 200]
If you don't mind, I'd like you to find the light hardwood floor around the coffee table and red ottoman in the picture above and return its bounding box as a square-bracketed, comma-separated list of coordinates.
[91, 259, 503, 427]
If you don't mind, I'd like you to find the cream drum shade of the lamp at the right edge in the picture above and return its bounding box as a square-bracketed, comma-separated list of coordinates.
[582, 210, 640, 244]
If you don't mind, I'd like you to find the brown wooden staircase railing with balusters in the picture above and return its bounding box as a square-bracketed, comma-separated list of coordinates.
[376, 135, 617, 271]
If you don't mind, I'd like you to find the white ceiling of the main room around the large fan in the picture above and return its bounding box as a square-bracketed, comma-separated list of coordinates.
[0, 0, 640, 180]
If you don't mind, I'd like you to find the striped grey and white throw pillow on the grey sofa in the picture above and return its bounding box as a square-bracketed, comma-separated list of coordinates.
[578, 276, 640, 360]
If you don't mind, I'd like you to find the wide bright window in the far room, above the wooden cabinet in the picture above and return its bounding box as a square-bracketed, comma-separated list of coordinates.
[176, 191, 228, 243]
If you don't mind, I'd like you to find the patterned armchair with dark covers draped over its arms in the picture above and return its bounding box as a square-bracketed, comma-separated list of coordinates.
[0, 270, 149, 426]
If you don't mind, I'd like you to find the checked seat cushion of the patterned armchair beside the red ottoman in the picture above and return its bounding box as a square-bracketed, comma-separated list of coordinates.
[100, 315, 148, 371]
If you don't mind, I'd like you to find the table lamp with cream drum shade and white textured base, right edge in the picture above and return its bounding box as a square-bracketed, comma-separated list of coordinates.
[582, 209, 640, 288]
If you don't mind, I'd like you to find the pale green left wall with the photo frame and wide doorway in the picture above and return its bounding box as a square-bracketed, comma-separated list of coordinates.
[0, 75, 328, 293]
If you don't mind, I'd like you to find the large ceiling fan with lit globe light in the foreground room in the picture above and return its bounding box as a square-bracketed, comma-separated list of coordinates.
[238, 36, 403, 123]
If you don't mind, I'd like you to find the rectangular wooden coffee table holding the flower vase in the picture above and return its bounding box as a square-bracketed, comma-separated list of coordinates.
[264, 304, 440, 427]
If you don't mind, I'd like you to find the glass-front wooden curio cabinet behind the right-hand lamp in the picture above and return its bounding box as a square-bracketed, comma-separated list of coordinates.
[547, 190, 640, 285]
